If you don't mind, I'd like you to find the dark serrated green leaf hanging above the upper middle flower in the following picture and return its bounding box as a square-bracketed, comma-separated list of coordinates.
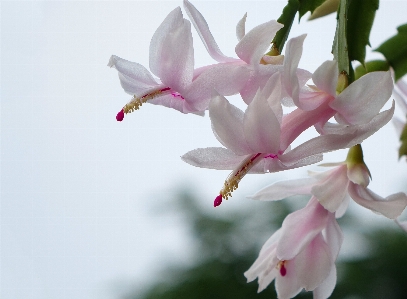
[272, 0, 300, 53]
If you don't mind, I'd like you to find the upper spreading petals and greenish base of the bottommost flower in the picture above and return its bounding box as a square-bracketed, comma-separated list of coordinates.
[250, 146, 407, 219]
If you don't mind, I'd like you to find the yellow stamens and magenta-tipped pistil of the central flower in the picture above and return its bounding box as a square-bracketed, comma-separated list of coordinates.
[213, 153, 265, 207]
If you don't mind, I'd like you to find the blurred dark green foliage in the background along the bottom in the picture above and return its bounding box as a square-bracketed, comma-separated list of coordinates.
[125, 192, 407, 299]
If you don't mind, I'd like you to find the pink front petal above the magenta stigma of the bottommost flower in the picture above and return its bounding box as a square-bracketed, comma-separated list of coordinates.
[277, 197, 329, 260]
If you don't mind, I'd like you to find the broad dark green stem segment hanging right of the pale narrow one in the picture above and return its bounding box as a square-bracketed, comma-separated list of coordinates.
[347, 0, 379, 64]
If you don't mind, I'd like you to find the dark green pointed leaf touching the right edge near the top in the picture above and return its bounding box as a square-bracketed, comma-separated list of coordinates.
[375, 24, 407, 81]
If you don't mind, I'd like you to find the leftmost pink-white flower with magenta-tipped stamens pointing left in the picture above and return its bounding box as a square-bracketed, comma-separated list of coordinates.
[108, 7, 249, 121]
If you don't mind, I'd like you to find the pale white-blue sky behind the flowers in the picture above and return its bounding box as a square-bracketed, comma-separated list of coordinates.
[0, 1, 407, 299]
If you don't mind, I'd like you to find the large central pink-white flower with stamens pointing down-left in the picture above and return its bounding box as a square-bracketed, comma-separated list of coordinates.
[182, 64, 394, 206]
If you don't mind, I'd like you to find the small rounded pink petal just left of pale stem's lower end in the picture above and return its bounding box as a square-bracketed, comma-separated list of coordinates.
[312, 60, 339, 96]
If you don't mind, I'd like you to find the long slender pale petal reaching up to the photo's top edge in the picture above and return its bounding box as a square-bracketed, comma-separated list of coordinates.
[184, 0, 236, 62]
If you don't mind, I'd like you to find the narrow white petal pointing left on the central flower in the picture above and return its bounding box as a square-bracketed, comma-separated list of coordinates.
[181, 147, 243, 170]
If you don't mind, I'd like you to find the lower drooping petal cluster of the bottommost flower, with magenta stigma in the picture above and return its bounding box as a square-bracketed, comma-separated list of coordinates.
[244, 197, 343, 299]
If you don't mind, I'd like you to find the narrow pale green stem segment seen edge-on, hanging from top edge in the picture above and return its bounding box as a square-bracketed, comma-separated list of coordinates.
[332, 0, 350, 75]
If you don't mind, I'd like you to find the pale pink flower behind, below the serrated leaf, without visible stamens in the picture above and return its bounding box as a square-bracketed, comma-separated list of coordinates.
[184, 0, 311, 108]
